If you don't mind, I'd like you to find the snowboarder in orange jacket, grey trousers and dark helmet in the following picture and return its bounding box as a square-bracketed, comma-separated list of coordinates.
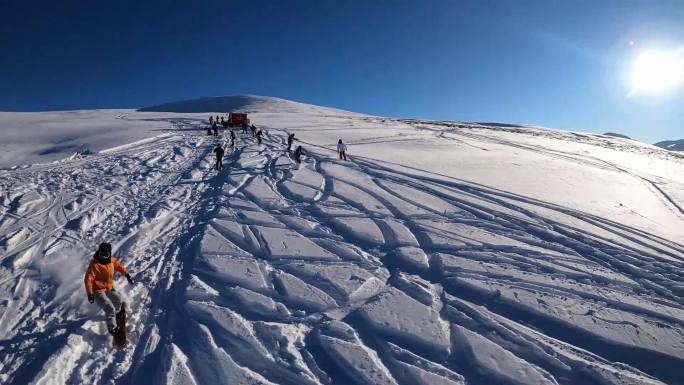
[84, 242, 133, 335]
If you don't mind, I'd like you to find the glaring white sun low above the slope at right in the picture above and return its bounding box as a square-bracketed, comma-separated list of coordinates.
[632, 52, 684, 93]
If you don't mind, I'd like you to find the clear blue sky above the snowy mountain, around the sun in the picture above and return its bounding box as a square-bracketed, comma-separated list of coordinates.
[0, 0, 684, 141]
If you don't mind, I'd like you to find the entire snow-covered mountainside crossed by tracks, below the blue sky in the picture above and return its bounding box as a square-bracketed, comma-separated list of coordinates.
[0, 96, 684, 385]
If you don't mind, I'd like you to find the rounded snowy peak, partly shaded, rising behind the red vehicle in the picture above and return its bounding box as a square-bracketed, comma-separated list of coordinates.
[138, 95, 356, 113]
